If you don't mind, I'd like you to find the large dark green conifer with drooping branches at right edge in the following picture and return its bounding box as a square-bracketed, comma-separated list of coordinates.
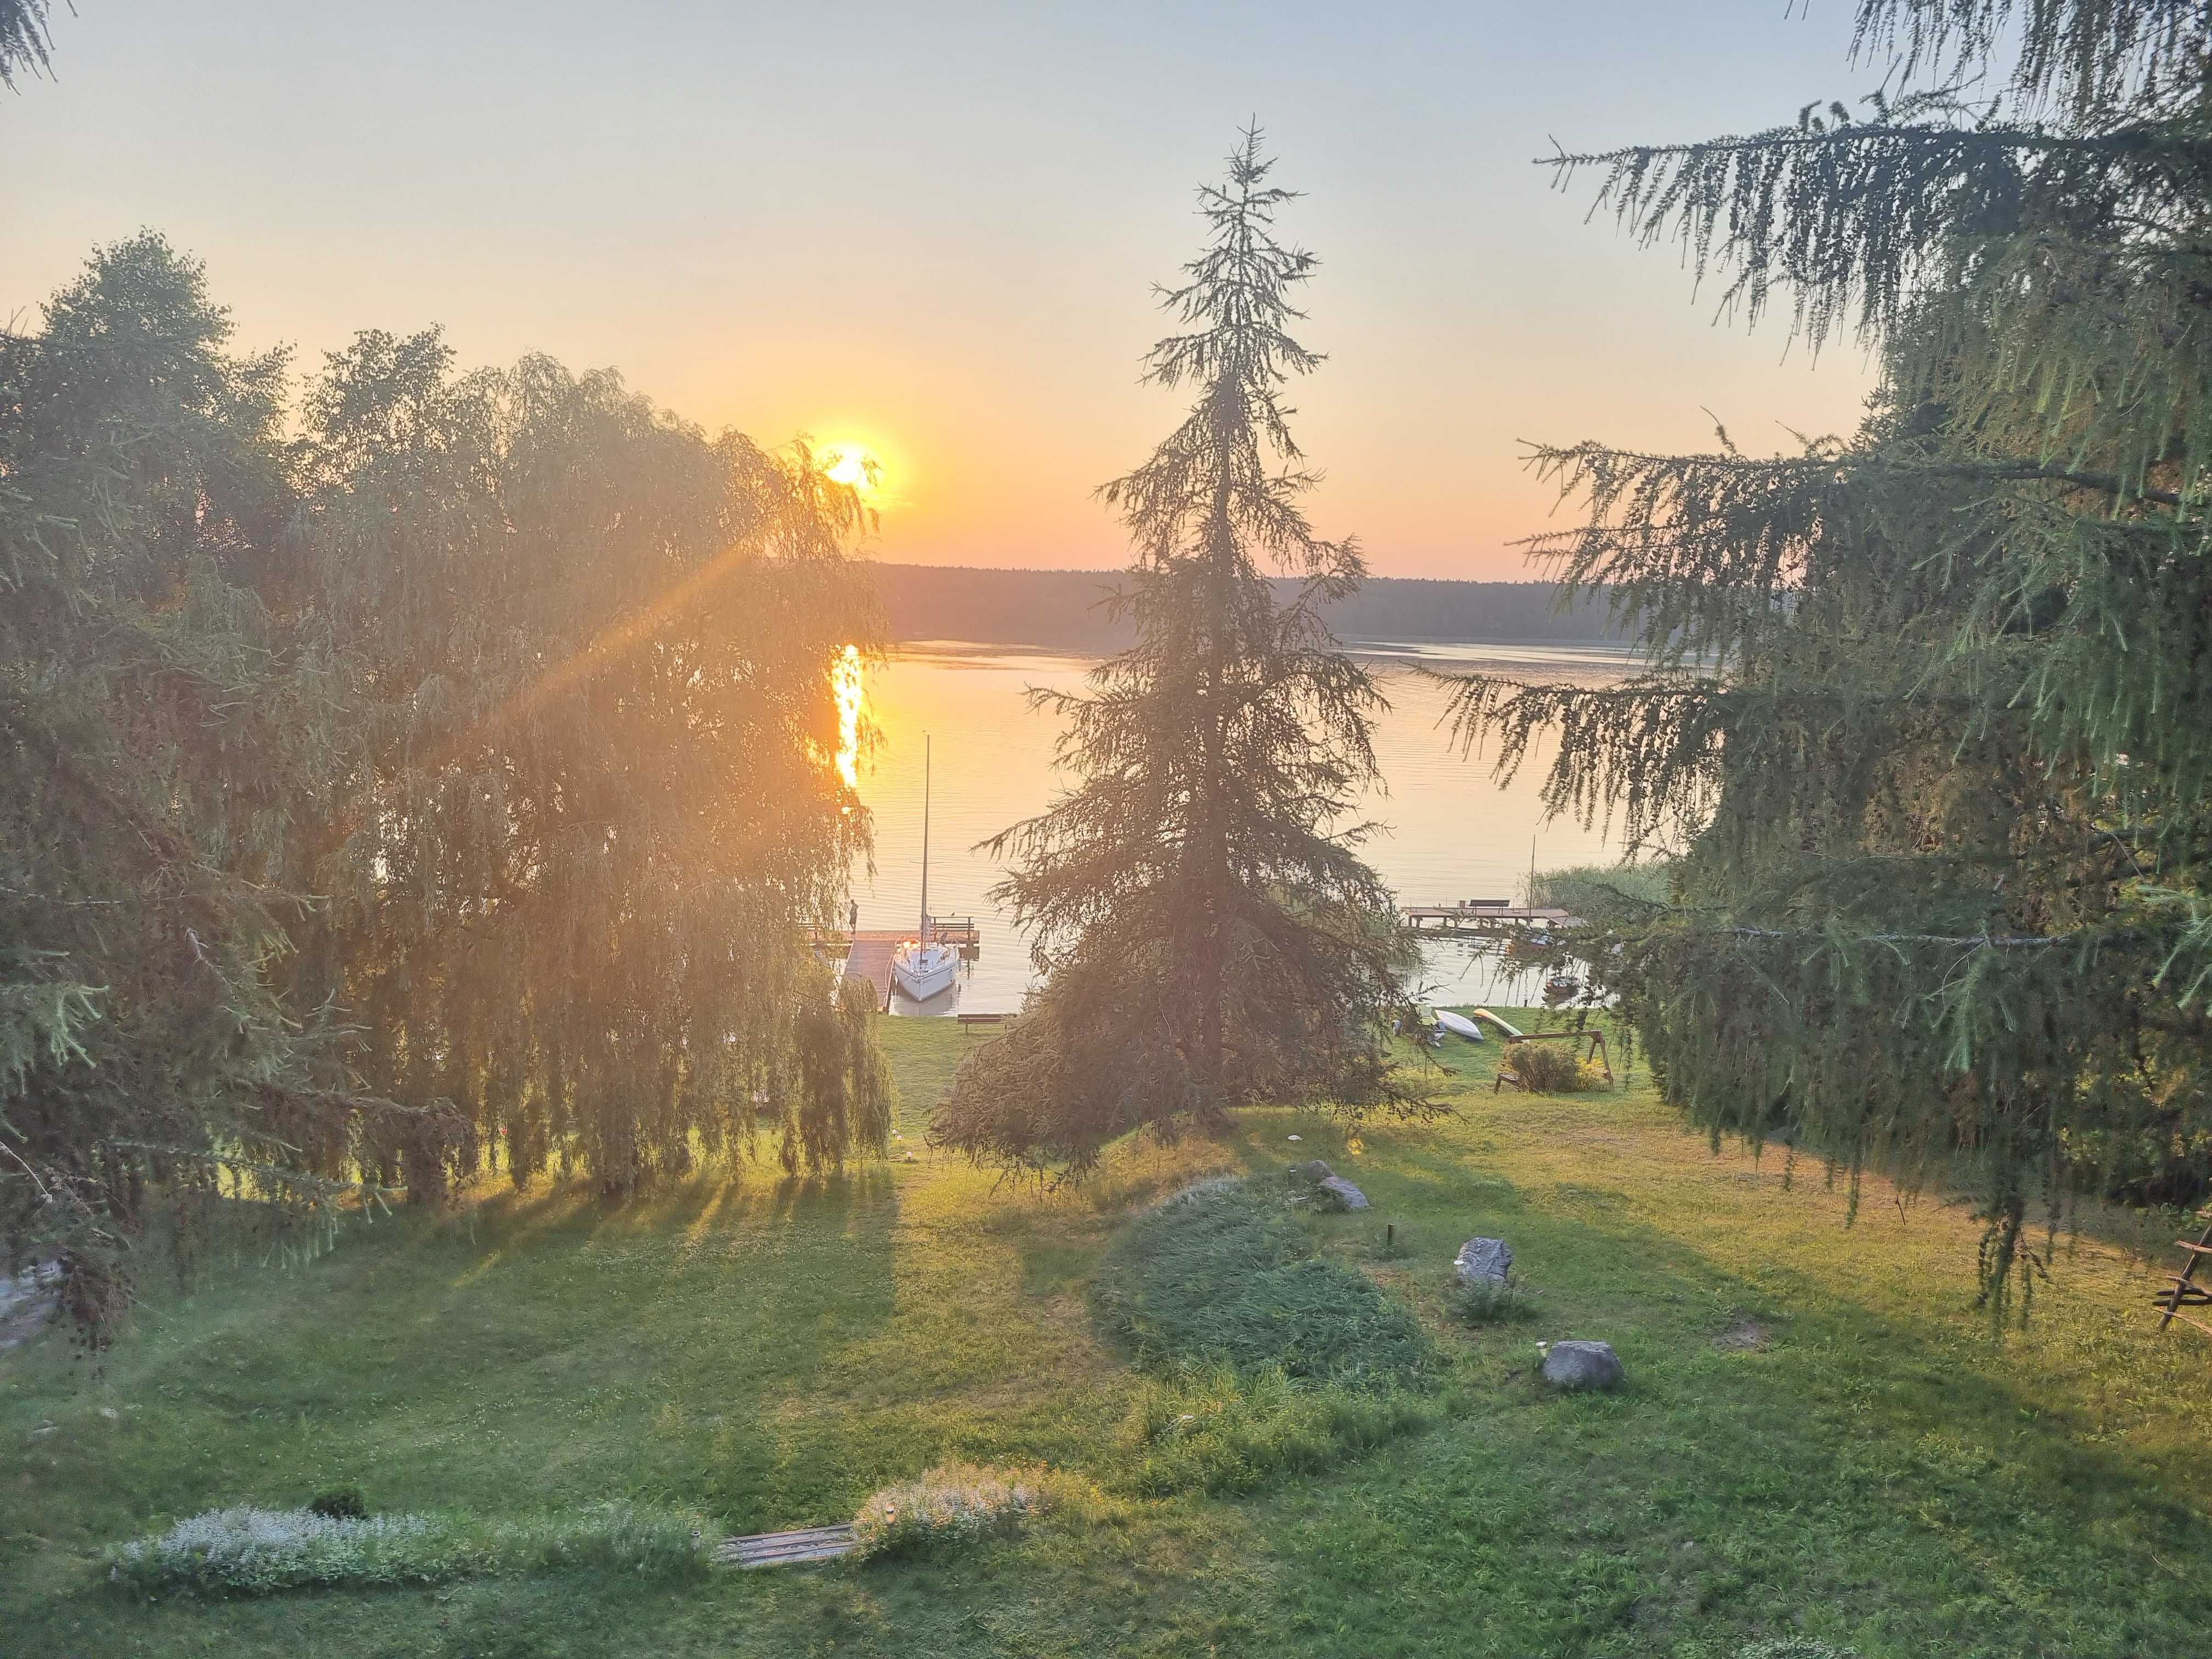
[1458, 0, 2212, 1307]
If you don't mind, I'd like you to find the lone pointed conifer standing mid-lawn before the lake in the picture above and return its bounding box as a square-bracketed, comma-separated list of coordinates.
[934, 131, 1423, 1175]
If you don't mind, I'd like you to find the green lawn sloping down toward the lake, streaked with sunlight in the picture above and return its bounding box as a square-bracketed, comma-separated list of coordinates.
[0, 1020, 2212, 1659]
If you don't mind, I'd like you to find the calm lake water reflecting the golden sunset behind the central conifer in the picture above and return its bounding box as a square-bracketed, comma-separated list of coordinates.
[854, 641, 1628, 1015]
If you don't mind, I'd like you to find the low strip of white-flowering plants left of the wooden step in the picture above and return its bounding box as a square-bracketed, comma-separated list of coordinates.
[106, 1504, 708, 1595]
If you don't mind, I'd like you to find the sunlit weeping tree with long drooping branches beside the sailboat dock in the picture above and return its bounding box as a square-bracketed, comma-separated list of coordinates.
[287, 334, 889, 1194]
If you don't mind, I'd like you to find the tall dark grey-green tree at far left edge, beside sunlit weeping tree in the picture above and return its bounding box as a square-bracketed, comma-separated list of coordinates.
[0, 234, 400, 1340]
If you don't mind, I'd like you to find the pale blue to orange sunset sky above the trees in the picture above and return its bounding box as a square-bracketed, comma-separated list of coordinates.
[0, 0, 1880, 579]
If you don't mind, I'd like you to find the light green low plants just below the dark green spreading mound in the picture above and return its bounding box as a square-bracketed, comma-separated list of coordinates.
[1124, 1367, 1429, 1498]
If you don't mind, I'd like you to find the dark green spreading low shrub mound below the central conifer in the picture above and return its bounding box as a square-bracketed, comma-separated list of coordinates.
[1095, 1181, 1438, 1391]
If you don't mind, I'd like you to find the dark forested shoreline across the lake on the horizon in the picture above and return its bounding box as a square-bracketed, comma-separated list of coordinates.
[876, 564, 1621, 650]
